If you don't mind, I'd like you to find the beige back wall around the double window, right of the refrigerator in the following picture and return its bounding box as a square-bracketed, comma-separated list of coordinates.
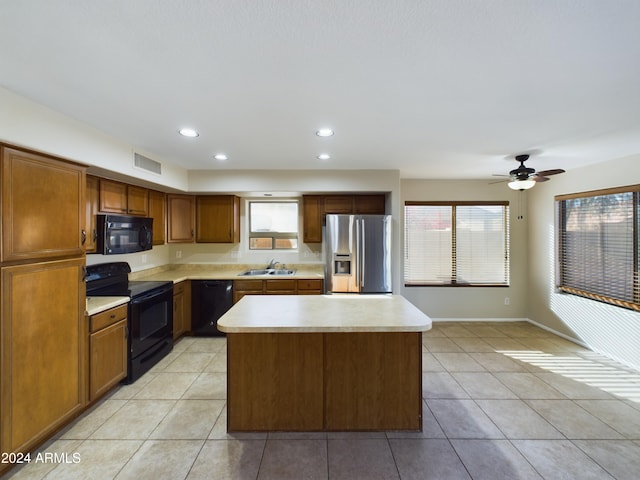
[400, 180, 528, 319]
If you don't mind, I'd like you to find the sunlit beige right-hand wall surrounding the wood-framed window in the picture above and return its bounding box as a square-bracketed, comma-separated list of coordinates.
[528, 155, 640, 368]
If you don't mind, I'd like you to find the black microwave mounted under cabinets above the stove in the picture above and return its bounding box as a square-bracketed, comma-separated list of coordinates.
[97, 215, 153, 255]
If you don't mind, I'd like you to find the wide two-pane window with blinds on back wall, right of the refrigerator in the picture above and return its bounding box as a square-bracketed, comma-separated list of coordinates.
[404, 202, 509, 286]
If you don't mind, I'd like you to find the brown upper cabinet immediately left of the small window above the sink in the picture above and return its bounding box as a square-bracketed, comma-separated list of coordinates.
[196, 195, 240, 243]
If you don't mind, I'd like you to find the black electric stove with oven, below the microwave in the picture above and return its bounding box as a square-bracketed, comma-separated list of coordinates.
[86, 262, 173, 383]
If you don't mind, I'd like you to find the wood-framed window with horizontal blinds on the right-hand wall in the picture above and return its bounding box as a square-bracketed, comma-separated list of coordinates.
[555, 185, 640, 310]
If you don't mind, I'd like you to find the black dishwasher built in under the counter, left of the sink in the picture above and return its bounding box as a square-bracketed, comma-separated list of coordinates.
[191, 280, 233, 336]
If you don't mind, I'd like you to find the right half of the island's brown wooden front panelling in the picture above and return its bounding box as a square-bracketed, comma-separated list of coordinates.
[325, 332, 422, 431]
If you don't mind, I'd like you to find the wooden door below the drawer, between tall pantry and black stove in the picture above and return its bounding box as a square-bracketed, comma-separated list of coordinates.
[89, 318, 127, 401]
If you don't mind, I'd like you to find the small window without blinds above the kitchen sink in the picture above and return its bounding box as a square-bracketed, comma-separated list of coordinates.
[249, 201, 298, 250]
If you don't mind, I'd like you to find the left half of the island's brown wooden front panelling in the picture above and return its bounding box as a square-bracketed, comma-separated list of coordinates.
[227, 333, 324, 432]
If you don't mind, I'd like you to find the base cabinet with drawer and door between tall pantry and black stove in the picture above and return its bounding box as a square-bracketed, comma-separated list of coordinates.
[89, 305, 128, 402]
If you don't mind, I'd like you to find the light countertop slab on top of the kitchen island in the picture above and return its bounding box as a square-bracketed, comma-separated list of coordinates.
[218, 295, 431, 333]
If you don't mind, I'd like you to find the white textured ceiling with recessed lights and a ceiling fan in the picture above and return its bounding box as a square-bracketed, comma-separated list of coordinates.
[0, 0, 640, 179]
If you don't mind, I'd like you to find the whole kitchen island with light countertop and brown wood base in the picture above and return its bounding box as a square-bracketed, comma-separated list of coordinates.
[218, 295, 431, 432]
